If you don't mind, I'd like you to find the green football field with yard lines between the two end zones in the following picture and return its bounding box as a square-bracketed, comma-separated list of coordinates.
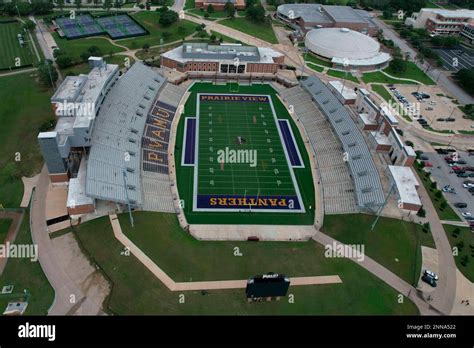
[196, 94, 306, 210]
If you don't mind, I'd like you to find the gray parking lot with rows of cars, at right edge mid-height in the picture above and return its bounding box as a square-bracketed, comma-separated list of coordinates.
[423, 151, 474, 220]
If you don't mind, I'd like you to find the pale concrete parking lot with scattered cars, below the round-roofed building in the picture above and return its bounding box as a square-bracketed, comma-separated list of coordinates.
[391, 85, 474, 131]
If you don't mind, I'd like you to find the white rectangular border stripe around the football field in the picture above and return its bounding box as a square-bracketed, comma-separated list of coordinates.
[193, 93, 306, 213]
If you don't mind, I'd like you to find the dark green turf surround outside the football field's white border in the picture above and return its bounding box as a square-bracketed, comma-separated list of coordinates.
[175, 83, 315, 225]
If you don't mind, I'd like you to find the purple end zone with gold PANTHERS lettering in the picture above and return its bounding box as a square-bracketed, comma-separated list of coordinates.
[197, 194, 301, 211]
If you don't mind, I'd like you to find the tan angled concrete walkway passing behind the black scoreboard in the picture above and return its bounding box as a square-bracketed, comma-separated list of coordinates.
[109, 214, 342, 291]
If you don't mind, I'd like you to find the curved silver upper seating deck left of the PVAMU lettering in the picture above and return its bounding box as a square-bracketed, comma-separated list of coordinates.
[86, 62, 166, 206]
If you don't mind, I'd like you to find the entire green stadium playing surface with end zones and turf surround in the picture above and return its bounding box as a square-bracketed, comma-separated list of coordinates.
[176, 84, 314, 224]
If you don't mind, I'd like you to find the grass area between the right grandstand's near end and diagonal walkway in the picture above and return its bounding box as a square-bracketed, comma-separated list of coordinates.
[322, 214, 435, 284]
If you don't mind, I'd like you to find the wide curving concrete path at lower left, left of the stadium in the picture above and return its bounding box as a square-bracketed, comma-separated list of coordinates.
[30, 165, 101, 315]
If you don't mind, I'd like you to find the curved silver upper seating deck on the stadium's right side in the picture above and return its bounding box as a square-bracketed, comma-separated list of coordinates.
[302, 76, 385, 210]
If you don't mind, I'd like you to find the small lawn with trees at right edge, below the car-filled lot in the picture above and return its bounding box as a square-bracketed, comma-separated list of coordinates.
[443, 225, 474, 282]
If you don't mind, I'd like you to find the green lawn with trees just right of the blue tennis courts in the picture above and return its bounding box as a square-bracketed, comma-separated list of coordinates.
[117, 11, 197, 49]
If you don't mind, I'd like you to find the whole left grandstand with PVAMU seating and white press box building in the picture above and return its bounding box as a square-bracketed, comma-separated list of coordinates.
[38, 57, 175, 215]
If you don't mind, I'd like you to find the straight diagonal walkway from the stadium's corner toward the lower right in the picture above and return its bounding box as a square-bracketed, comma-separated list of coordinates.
[313, 232, 440, 315]
